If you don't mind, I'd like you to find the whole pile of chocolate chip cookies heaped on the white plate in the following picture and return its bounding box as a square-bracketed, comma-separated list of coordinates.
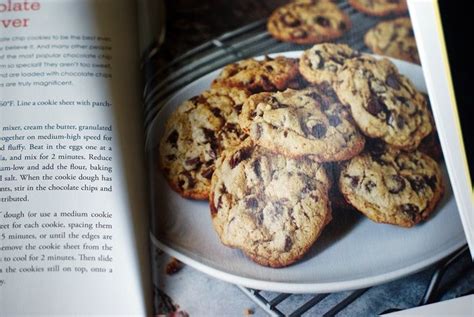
[159, 44, 443, 267]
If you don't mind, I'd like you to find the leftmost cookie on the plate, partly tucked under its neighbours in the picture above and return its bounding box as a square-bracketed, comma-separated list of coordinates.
[159, 87, 248, 200]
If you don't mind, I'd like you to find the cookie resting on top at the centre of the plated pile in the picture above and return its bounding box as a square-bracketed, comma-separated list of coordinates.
[239, 87, 365, 162]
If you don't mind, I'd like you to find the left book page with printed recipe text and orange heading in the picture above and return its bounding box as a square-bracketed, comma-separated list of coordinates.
[0, 0, 151, 315]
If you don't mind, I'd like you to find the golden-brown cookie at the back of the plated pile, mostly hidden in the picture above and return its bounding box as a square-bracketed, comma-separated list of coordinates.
[212, 56, 299, 93]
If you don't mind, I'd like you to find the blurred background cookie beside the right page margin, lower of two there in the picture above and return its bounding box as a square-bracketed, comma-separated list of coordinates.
[364, 18, 420, 64]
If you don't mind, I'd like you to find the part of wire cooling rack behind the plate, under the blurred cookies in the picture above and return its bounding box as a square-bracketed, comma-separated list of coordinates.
[142, 1, 386, 132]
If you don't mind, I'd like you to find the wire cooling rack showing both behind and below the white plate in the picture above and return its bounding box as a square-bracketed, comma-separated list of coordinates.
[142, 0, 474, 317]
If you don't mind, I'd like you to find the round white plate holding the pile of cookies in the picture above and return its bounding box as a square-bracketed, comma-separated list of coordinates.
[148, 52, 466, 293]
